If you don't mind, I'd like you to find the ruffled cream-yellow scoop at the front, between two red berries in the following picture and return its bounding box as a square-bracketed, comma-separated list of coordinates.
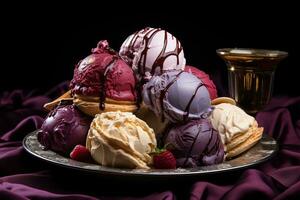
[86, 111, 156, 169]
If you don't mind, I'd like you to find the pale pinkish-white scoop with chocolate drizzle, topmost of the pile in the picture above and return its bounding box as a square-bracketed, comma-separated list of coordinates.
[119, 28, 186, 81]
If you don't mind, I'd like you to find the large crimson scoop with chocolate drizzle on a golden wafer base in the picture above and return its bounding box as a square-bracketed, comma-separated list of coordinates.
[70, 40, 137, 116]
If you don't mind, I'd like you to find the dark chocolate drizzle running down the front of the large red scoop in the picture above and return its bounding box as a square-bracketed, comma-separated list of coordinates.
[99, 56, 118, 110]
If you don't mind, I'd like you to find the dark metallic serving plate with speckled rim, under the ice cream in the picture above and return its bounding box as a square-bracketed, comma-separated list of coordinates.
[23, 131, 278, 177]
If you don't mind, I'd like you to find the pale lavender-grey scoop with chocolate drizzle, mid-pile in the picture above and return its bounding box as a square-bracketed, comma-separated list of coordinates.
[143, 70, 211, 123]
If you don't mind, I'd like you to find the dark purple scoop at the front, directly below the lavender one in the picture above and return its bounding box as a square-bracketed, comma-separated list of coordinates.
[164, 119, 224, 168]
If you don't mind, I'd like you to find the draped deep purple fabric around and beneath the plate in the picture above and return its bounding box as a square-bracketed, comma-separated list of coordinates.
[0, 82, 300, 200]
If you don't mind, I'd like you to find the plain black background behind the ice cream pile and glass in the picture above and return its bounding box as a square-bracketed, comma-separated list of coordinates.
[0, 5, 300, 96]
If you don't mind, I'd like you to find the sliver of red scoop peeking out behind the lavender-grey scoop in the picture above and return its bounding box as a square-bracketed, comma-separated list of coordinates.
[184, 65, 218, 100]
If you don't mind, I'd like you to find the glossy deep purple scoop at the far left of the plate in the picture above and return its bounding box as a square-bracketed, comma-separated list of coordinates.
[38, 102, 91, 155]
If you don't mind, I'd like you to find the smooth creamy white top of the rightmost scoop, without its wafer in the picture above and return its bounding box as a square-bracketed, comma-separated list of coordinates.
[210, 103, 255, 144]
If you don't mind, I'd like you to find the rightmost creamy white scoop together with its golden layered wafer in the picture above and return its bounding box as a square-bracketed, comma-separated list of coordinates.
[210, 103, 263, 158]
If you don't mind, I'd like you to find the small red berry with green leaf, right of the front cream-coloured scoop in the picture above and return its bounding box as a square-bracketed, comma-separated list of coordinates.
[153, 149, 176, 169]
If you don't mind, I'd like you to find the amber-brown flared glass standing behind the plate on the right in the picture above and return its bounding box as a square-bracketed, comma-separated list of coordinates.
[217, 48, 288, 115]
